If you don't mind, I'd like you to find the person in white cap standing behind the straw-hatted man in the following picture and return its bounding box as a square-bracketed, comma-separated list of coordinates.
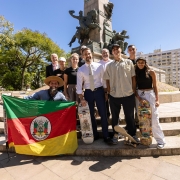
[53, 57, 66, 92]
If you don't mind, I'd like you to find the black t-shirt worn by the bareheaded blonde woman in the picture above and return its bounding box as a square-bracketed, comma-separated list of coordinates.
[64, 67, 78, 84]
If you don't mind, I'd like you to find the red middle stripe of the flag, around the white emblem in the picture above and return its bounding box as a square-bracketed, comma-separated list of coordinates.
[7, 106, 76, 145]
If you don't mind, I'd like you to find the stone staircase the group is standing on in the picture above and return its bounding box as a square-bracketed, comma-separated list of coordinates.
[0, 102, 180, 156]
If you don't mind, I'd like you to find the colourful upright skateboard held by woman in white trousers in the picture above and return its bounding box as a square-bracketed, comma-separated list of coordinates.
[138, 100, 152, 146]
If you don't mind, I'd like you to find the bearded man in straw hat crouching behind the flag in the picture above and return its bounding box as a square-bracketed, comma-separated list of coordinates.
[25, 76, 67, 101]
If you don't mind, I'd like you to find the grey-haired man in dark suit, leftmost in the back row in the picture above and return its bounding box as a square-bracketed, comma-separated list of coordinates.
[46, 53, 59, 77]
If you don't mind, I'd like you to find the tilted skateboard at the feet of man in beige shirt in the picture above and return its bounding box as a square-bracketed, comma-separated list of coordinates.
[114, 125, 139, 147]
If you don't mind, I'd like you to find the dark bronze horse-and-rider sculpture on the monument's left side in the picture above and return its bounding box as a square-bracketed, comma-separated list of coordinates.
[69, 10, 101, 47]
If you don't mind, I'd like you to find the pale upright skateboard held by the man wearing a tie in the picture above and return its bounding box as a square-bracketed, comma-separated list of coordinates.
[78, 103, 94, 144]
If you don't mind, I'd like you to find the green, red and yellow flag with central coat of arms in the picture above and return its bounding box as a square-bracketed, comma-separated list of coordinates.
[2, 95, 78, 156]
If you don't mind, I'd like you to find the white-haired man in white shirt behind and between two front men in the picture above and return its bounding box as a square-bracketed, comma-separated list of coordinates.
[99, 48, 113, 121]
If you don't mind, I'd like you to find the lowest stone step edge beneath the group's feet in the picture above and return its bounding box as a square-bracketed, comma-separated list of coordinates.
[0, 137, 180, 157]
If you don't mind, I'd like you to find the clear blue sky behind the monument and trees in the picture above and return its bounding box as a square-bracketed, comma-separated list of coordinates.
[0, 0, 180, 54]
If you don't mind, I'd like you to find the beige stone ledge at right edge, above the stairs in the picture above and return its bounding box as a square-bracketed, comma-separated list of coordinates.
[159, 91, 180, 103]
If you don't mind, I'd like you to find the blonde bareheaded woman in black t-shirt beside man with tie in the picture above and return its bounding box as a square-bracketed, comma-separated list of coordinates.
[64, 53, 79, 102]
